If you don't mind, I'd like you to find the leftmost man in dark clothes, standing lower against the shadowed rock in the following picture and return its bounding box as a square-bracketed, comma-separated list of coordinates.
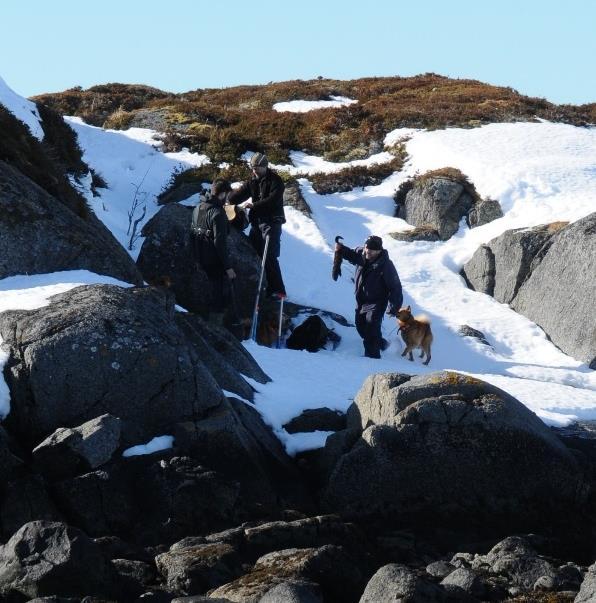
[191, 180, 236, 325]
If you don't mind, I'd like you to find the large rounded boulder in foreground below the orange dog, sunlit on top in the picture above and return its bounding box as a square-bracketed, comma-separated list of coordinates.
[324, 372, 587, 522]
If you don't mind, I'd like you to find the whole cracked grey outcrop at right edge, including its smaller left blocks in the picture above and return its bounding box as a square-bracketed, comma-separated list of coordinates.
[462, 213, 596, 368]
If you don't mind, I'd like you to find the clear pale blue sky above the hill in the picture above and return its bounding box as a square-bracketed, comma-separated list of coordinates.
[0, 0, 596, 104]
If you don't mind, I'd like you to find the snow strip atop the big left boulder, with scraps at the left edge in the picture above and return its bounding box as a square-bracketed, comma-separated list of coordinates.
[0, 270, 130, 419]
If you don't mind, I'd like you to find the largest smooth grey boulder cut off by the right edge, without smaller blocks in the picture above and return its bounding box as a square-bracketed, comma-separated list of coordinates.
[511, 217, 596, 369]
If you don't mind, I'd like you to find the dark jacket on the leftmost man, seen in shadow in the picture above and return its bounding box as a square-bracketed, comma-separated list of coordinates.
[192, 197, 231, 272]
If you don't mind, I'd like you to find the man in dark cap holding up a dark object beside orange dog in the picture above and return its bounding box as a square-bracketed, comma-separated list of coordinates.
[335, 235, 403, 358]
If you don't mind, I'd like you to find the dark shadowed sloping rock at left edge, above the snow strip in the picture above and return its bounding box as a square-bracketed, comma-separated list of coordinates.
[0, 161, 142, 284]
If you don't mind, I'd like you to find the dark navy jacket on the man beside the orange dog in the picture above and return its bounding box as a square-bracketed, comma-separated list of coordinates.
[341, 245, 403, 317]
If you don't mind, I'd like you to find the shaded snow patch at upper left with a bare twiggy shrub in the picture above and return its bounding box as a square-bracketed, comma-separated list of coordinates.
[65, 117, 209, 260]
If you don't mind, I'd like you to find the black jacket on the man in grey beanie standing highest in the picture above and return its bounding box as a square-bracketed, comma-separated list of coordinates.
[228, 169, 286, 224]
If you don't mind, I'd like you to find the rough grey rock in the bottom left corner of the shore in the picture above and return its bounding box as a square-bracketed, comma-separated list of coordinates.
[0, 521, 118, 599]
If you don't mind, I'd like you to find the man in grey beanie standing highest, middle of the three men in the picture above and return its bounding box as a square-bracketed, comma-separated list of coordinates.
[228, 153, 286, 298]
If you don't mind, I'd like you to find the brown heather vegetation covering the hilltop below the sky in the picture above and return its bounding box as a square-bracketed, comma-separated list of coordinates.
[34, 73, 596, 169]
